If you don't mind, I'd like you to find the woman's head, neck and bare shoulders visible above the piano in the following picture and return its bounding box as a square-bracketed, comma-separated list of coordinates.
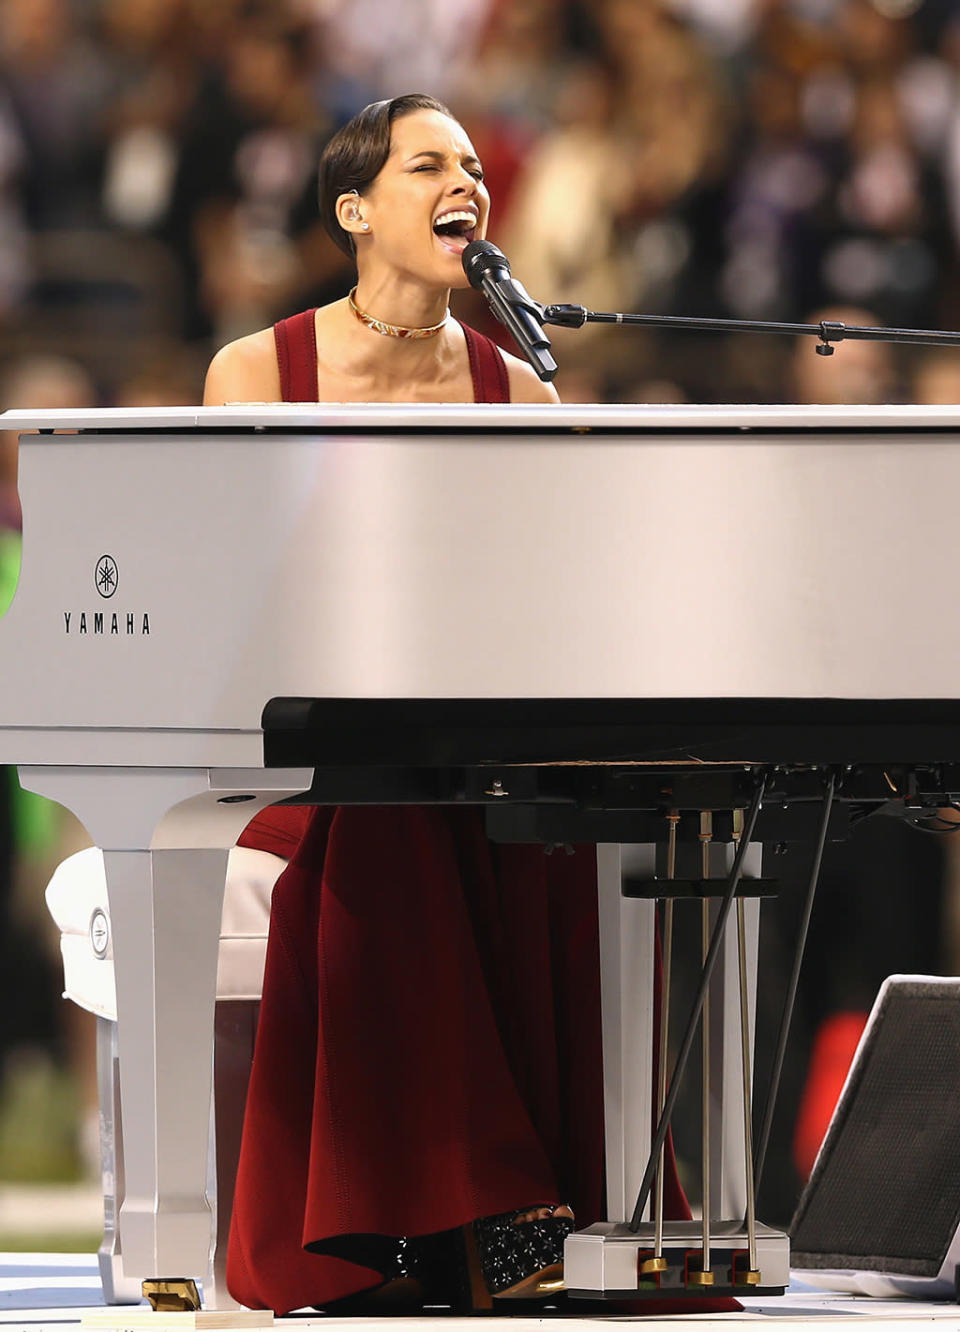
[204, 96, 558, 404]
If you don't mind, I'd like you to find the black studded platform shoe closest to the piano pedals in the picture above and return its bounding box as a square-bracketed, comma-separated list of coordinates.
[463, 1208, 574, 1309]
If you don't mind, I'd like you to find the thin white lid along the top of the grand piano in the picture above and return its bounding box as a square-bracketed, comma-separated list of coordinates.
[9, 402, 960, 436]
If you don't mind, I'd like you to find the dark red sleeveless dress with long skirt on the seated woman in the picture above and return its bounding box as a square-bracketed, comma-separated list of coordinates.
[228, 310, 688, 1313]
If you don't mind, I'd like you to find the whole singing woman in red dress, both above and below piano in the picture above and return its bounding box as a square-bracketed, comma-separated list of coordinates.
[204, 96, 688, 1313]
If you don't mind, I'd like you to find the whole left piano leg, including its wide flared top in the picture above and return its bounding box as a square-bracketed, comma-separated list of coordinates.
[20, 767, 310, 1303]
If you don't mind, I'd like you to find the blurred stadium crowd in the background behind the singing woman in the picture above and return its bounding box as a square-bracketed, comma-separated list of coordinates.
[0, 0, 960, 1241]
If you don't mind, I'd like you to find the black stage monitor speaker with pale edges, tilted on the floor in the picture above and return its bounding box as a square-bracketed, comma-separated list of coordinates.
[791, 976, 960, 1299]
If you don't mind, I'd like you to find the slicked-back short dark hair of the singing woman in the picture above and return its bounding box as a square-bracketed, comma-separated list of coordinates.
[320, 92, 457, 258]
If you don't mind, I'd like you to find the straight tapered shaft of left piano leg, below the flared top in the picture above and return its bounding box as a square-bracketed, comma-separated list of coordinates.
[104, 848, 226, 1279]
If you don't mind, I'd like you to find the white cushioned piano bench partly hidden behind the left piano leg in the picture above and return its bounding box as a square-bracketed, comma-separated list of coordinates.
[47, 847, 286, 1305]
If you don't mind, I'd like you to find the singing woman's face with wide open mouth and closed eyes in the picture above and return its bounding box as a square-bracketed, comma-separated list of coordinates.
[352, 111, 490, 286]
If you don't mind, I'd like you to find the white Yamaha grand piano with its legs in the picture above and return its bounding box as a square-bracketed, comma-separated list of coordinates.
[0, 405, 960, 1299]
